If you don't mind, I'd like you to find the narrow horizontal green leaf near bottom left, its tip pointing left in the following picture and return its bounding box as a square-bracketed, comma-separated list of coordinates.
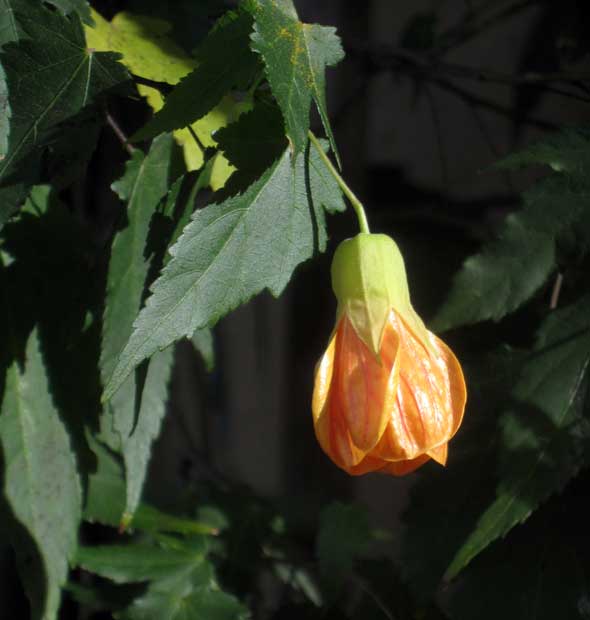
[76, 540, 207, 583]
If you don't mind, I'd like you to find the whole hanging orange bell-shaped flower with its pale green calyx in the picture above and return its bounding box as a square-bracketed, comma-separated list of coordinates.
[312, 233, 466, 476]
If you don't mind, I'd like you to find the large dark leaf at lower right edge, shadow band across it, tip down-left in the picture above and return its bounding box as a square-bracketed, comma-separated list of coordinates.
[446, 297, 590, 578]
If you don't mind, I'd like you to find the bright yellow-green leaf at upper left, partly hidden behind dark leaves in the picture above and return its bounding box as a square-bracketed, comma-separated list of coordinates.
[85, 9, 251, 190]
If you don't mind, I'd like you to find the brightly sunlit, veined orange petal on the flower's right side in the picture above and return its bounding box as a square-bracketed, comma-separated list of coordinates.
[372, 311, 466, 461]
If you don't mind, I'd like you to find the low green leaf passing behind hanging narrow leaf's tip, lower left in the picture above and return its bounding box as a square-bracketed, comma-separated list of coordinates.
[84, 440, 216, 535]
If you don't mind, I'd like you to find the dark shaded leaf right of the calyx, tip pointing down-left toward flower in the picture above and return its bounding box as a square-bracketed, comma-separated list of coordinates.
[431, 174, 590, 331]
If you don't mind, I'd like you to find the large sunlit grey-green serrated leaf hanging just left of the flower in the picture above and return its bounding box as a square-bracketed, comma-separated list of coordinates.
[104, 143, 343, 400]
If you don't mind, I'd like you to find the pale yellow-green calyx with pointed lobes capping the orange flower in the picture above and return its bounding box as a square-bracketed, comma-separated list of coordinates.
[332, 233, 428, 356]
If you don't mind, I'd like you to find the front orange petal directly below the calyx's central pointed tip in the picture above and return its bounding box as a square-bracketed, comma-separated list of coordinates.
[331, 315, 399, 452]
